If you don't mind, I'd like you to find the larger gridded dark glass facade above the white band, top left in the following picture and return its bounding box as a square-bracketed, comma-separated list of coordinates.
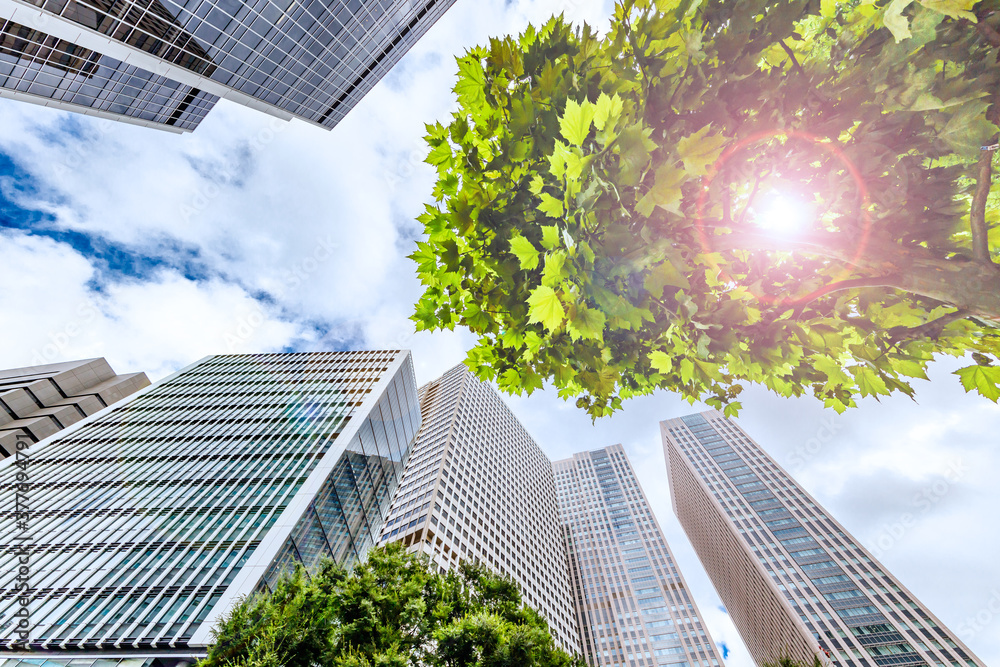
[22, 0, 454, 128]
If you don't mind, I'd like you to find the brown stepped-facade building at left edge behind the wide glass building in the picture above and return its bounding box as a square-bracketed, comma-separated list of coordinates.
[0, 357, 149, 460]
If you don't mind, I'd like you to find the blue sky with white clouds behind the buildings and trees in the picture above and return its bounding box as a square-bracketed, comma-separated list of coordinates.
[0, 0, 1000, 667]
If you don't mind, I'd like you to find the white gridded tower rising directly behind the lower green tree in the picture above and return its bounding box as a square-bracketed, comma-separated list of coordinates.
[382, 365, 579, 652]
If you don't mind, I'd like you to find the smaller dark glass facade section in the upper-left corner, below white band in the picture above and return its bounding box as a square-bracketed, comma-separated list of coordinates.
[0, 20, 218, 130]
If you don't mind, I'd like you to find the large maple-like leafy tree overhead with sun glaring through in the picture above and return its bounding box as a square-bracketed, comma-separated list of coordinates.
[411, 0, 1000, 418]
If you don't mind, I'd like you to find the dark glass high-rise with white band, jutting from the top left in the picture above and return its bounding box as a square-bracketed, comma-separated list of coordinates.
[0, 0, 454, 131]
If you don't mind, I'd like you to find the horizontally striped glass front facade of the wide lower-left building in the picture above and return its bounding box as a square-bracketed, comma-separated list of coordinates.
[0, 351, 419, 650]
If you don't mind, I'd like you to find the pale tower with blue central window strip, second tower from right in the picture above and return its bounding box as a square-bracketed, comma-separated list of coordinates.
[553, 445, 722, 667]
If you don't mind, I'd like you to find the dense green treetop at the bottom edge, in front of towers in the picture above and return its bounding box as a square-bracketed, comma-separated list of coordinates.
[200, 544, 583, 667]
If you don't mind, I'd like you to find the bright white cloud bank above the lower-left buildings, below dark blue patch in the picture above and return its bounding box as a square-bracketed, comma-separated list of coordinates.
[0, 232, 310, 379]
